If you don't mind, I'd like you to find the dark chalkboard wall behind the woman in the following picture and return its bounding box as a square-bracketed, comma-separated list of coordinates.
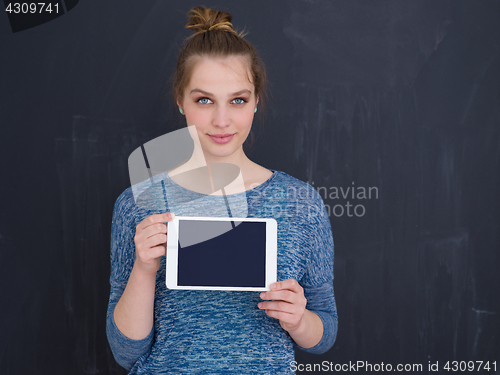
[0, 0, 500, 374]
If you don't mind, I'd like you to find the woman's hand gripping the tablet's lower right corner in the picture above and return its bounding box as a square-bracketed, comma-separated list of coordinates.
[259, 279, 307, 332]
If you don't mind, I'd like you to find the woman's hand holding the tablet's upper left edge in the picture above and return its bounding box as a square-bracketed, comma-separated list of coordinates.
[134, 213, 175, 275]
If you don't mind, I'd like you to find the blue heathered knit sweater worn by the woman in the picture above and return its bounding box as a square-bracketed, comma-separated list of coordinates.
[106, 170, 337, 375]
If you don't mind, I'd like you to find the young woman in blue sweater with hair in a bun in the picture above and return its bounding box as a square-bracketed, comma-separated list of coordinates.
[107, 7, 337, 374]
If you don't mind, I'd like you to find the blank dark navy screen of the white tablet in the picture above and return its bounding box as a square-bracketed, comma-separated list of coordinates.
[177, 220, 266, 287]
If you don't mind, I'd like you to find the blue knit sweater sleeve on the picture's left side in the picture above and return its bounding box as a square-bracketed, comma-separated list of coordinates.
[106, 190, 154, 370]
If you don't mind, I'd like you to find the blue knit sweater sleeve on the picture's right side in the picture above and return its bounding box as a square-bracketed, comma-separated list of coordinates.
[297, 190, 338, 354]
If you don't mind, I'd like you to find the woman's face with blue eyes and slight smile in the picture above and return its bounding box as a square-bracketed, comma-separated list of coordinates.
[177, 56, 258, 162]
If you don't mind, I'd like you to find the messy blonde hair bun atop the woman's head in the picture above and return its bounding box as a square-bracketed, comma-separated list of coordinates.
[186, 5, 241, 37]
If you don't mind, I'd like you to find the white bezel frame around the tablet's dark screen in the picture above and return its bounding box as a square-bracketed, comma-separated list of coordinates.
[166, 216, 278, 291]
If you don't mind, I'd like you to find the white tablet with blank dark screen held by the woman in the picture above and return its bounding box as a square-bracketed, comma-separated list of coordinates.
[166, 216, 277, 291]
